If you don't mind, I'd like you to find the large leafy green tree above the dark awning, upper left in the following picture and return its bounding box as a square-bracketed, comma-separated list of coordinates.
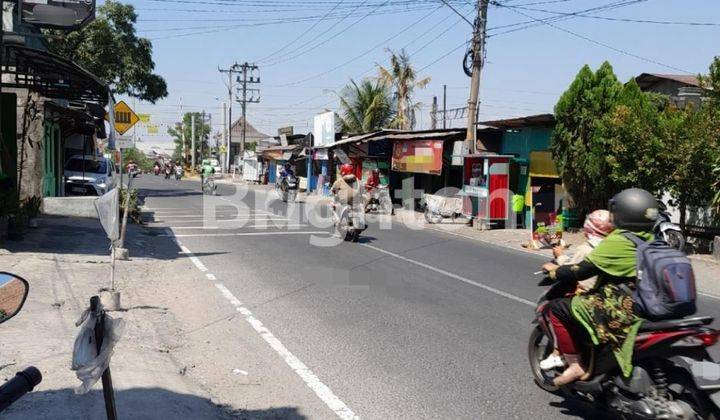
[47, 0, 168, 103]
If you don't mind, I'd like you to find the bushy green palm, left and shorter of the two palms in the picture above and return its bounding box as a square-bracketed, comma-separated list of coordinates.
[338, 79, 394, 133]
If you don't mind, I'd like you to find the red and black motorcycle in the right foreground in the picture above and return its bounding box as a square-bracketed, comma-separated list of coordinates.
[528, 273, 720, 420]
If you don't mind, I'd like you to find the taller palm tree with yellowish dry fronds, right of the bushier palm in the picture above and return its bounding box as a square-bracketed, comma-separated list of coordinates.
[377, 49, 430, 130]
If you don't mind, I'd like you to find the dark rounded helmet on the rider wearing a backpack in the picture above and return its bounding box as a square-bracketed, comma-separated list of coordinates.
[608, 188, 659, 232]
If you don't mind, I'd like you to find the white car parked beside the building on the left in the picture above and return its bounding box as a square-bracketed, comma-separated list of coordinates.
[64, 155, 118, 196]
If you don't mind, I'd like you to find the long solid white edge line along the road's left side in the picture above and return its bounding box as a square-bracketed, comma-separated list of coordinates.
[170, 232, 360, 420]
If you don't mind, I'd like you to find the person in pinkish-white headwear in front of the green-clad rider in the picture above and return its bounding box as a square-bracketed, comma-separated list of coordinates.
[540, 210, 614, 370]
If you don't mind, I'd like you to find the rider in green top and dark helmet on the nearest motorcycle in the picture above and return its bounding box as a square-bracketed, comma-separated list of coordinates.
[543, 188, 658, 386]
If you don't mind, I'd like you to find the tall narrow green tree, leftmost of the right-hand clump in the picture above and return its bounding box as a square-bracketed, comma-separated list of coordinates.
[550, 62, 622, 214]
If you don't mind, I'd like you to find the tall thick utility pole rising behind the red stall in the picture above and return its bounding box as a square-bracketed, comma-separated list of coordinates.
[465, 0, 490, 153]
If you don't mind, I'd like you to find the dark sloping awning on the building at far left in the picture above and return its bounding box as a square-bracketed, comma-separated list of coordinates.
[2, 45, 108, 104]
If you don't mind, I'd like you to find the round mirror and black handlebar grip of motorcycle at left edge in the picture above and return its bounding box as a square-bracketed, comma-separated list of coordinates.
[0, 272, 42, 412]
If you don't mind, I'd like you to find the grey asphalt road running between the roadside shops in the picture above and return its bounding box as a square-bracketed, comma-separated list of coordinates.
[136, 175, 720, 419]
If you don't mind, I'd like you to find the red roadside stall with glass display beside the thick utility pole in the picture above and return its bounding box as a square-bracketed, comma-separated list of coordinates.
[462, 154, 513, 229]
